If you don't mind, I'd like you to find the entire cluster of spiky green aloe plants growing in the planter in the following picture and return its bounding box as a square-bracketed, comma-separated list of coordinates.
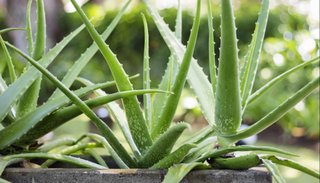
[0, 0, 319, 182]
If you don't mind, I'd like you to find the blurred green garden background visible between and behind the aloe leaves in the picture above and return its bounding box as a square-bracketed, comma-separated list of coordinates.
[0, 0, 320, 182]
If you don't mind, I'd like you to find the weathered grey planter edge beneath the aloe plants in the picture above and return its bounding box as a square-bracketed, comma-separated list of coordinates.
[2, 167, 272, 183]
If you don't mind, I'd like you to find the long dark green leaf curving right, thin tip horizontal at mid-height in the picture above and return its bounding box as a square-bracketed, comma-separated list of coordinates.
[16, 89, 161, 146]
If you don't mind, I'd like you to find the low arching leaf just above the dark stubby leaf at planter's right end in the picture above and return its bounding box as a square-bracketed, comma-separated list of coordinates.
[197, 145, 296, 161]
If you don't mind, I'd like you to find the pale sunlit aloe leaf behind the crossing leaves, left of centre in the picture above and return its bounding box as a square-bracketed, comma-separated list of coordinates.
[76, 79, 141, 159]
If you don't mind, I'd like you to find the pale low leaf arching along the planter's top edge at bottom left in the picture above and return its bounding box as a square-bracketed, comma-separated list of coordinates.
[2, 153, 106, 169]
